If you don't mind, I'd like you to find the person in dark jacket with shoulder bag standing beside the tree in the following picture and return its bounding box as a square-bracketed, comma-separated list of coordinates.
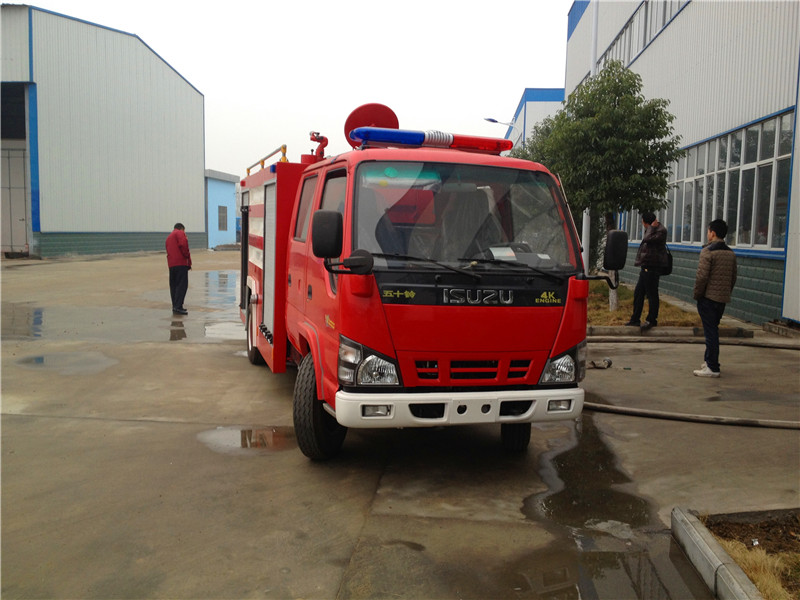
[625, 212, 667, 331]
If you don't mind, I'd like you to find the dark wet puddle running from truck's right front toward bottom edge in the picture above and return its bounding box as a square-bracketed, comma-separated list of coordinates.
[518, 413, 707, 599]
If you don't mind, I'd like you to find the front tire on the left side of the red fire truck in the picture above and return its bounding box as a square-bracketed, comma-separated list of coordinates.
[292, 353, 347, 460]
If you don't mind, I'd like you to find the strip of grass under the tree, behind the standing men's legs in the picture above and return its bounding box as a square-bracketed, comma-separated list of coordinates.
[589, 281, 702, 327]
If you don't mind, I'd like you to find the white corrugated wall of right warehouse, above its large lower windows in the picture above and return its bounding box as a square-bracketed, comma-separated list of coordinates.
[636, 1, 800, 145]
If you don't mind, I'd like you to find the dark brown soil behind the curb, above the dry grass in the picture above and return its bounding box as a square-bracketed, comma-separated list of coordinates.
[704, 508, 800, 598]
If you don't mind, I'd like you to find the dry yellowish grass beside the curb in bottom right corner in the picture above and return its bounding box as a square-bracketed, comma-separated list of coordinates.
[717, 538, 800, 600]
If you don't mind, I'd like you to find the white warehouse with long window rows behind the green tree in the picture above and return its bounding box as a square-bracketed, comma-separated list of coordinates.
[565, 0, 800, 323]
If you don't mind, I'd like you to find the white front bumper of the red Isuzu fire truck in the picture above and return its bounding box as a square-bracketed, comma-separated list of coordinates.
[328, 387, 583, 428]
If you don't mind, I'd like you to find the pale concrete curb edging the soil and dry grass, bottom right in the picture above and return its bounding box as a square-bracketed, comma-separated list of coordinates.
[672, 507, 764, 600]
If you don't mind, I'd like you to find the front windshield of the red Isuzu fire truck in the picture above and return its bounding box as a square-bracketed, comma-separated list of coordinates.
[353, 162, 580, 271]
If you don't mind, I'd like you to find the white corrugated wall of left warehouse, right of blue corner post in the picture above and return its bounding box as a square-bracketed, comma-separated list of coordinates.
[30, 9, 205, 234]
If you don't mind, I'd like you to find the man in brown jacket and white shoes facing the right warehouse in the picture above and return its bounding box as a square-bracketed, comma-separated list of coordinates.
[693, 219, 737, 377]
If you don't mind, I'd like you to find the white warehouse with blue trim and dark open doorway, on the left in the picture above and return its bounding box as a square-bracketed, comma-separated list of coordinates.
[0, 4, 206, 256]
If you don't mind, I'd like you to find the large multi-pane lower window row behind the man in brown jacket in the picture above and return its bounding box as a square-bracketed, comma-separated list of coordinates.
[621, 111, 794, 250]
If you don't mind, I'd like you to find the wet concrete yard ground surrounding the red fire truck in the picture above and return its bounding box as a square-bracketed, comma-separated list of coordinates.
[1, 251, 800, 598]
